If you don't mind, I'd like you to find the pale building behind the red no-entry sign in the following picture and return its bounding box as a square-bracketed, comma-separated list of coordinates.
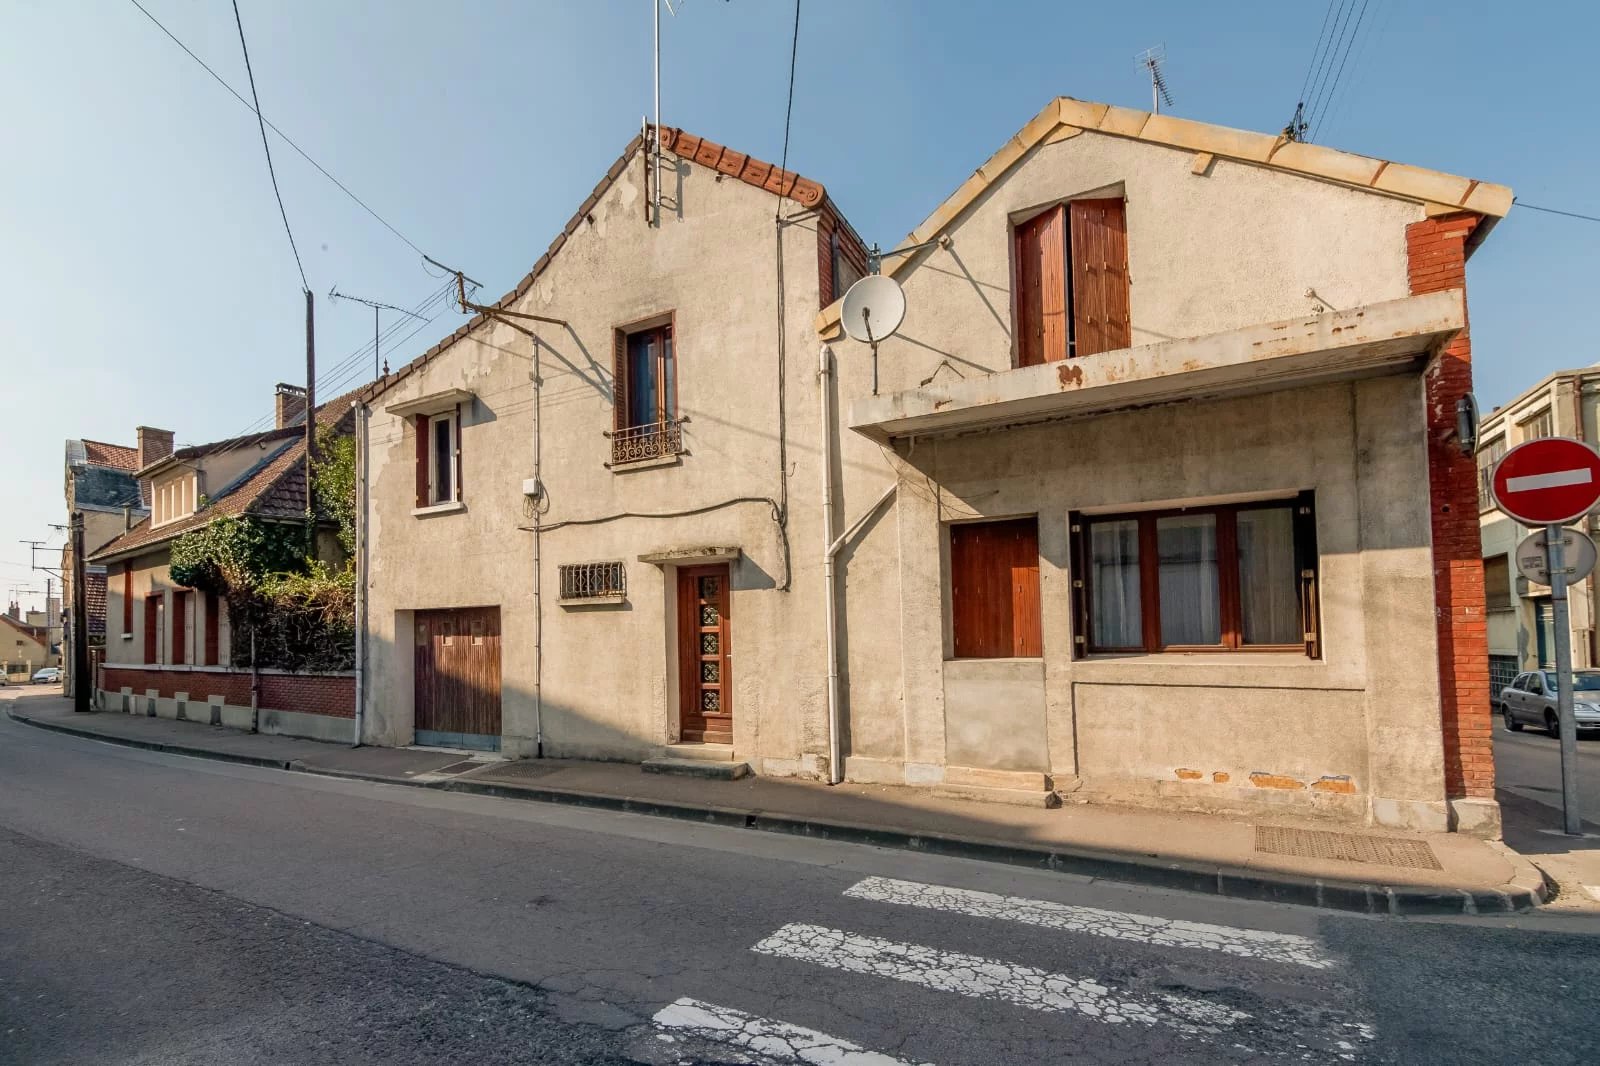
[1478, 367, 1600, 693]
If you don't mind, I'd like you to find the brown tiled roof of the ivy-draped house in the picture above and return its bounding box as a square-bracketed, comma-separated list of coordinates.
[90, 389, 360, 563]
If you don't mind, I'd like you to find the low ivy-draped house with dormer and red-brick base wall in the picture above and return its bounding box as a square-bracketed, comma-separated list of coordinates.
[88, 384, 355, 741]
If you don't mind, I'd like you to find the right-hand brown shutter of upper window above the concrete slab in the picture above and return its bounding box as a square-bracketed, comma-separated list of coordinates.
[1070, 198, 1133, 355]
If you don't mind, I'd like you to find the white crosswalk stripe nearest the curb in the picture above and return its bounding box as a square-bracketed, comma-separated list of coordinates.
[845, 877, 1334, 970]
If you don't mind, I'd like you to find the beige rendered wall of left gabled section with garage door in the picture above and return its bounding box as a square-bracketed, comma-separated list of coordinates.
[365, 143, 827, 773]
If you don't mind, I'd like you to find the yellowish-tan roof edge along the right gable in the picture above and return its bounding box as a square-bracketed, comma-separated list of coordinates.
[816, 96, 1512, 333]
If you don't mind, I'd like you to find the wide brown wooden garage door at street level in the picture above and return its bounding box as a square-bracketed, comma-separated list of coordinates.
[414, 607, 501, 751]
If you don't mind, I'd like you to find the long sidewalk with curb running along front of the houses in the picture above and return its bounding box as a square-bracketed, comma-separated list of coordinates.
[6, 696, 1549, 914]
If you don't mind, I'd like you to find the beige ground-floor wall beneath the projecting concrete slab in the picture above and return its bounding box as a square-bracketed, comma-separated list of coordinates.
[846, 376, 1445, 828]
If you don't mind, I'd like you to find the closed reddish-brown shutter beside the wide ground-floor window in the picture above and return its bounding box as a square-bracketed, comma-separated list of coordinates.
[950, 519, 1043, 659]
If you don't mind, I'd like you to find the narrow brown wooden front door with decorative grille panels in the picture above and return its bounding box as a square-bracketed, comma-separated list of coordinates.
[678, 563, 733, 744]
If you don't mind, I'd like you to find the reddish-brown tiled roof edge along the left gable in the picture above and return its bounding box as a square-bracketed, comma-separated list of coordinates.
[358, 126, 859, 403]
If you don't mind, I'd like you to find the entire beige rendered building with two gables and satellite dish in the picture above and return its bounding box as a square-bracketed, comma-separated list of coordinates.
[362, 99, 1510, 832]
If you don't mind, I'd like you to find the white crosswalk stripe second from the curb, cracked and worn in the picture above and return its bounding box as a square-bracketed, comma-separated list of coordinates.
[750, 924, 1250, 1034]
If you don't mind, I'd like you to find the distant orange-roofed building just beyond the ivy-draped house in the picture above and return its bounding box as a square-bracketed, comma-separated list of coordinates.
[61, 440, 149, 695]
